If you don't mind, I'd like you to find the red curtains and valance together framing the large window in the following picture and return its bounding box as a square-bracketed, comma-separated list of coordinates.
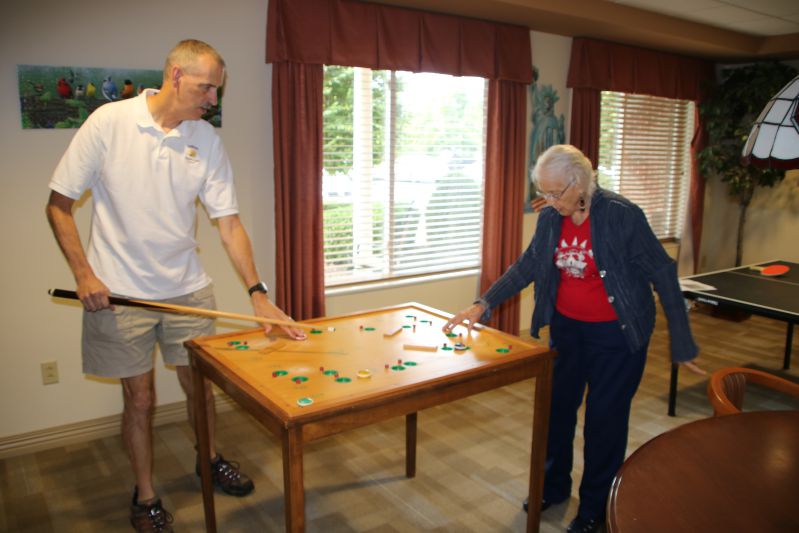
[266, 0, 533, 324]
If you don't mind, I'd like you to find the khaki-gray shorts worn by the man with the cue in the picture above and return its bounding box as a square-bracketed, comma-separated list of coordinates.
[82, 285, 216, 378]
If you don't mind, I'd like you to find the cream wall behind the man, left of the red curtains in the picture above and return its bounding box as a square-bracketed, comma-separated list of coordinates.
[0, 0, 274, 438]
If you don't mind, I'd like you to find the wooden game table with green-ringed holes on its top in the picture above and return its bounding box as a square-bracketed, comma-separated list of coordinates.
[186, 303, 553, 532]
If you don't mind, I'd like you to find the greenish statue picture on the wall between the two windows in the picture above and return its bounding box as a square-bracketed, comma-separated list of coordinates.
[524, 66, 566, 213]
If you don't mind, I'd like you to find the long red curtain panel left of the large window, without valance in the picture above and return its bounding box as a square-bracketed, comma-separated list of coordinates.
[272, 63, 325, 320]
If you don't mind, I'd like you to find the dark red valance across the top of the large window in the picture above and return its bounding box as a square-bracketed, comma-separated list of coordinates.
[266, 0, 533, 83]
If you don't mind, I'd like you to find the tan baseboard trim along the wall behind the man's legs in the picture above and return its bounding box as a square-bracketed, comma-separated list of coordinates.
[0, 393, 235, 459]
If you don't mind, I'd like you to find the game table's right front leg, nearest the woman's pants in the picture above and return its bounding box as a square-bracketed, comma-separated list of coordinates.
[527, 352, 554, 533]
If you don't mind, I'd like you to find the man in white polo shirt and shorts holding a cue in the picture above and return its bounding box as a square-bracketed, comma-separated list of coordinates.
[47, 40, 305, 531]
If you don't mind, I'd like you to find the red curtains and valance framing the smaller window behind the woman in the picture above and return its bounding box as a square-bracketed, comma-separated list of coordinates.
[566, 38, 714, 265]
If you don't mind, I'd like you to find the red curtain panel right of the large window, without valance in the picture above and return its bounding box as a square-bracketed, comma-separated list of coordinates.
[480, 80, 527, 335]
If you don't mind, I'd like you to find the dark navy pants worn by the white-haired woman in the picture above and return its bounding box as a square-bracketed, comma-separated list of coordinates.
[544, 312, 647, 520]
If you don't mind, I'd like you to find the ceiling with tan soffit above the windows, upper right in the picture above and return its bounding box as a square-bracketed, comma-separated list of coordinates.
[371, 0, 799, 62]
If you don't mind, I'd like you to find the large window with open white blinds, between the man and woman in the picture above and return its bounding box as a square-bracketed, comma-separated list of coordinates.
[322, 66, 486, 287]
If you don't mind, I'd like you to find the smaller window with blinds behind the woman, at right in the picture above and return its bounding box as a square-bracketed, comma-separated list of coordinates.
[599, 91, 694, 239]
